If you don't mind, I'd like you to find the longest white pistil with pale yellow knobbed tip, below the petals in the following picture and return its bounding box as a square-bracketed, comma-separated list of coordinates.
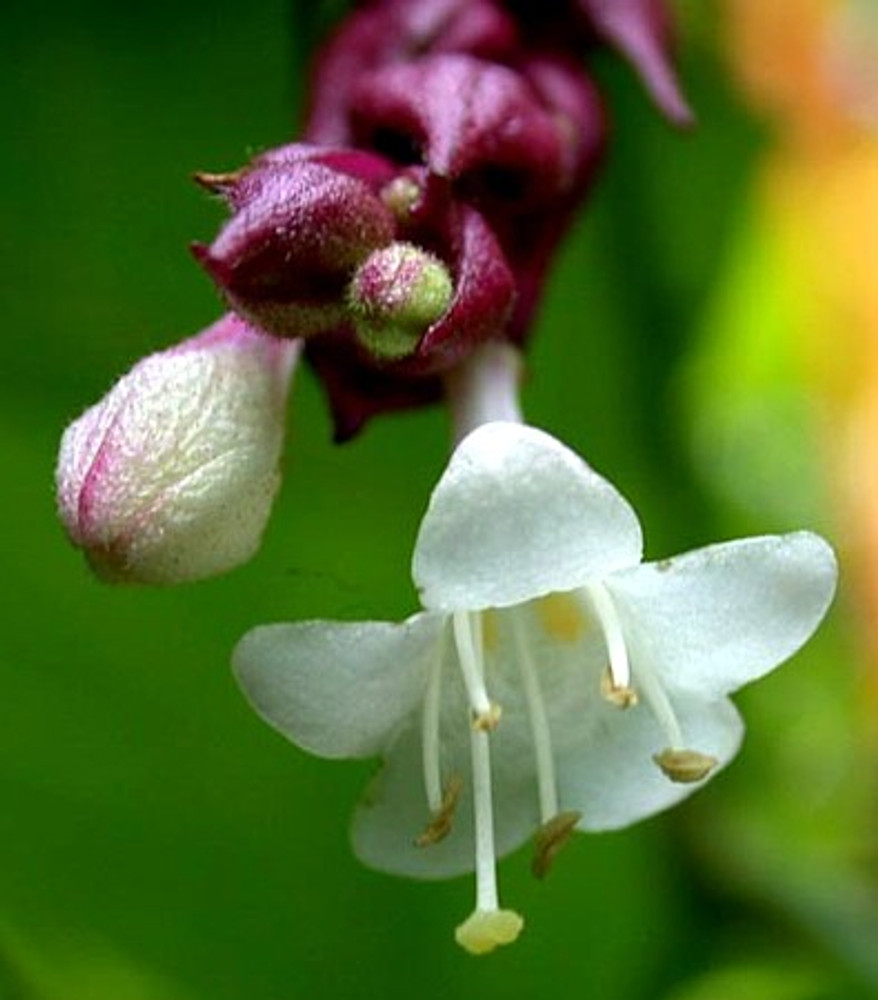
[454, 729, 524, 955]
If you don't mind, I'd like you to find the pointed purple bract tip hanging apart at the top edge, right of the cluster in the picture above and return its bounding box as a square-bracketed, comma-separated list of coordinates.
[577, 0, 694, 126]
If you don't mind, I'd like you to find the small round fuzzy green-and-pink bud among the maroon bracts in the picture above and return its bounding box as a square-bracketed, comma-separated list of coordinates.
[348, 243, 454, 360]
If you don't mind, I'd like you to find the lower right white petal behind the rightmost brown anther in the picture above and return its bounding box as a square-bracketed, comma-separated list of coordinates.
[558, 698, 744, 831]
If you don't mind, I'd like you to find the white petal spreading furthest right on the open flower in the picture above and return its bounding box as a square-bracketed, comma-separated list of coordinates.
[604, 531, 837, 699]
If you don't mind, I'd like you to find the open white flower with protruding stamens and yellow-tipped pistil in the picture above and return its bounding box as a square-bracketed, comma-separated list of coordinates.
[234, 423, 836, 953]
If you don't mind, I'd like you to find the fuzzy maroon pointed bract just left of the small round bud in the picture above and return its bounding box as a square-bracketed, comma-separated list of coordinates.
[193, 147, 395, 337]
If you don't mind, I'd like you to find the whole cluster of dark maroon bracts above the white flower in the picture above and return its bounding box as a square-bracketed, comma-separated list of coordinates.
[194, 0, 689, 438]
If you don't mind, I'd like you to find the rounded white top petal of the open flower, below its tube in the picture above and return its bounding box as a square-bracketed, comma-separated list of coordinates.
[412, 422, 642, 611]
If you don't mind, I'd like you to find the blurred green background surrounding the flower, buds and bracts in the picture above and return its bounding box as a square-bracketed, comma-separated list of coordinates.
[0, 0, 878, 1000]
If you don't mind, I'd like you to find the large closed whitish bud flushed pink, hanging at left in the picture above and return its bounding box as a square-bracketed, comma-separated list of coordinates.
[56, 315, 299, 584]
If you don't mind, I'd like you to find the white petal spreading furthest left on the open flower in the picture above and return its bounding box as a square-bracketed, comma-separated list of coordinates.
[232, 614, 443, 757]
